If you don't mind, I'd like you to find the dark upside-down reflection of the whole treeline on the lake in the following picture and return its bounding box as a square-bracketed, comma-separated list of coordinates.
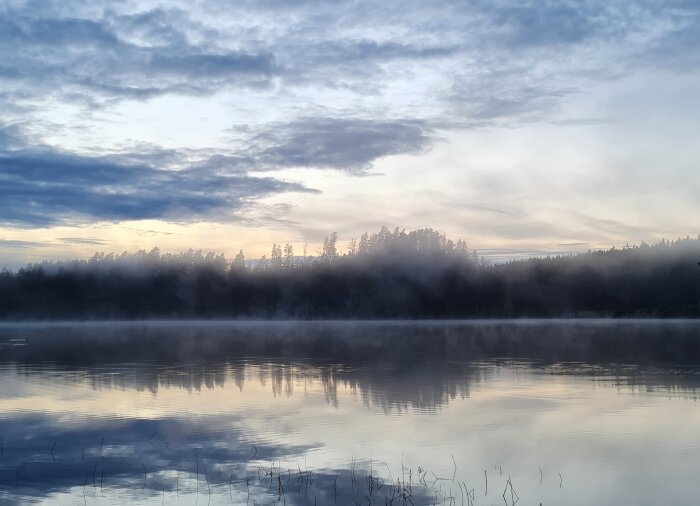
[0, 321, 700, 410]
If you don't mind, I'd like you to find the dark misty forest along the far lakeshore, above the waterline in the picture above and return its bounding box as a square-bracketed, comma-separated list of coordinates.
[0, 228, 700, 319]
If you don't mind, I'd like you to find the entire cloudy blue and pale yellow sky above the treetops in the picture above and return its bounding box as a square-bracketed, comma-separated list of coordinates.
[0, 0, 700, 268]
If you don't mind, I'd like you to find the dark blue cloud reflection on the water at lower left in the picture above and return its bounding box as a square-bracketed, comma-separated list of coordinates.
[0, 414, 440, 504]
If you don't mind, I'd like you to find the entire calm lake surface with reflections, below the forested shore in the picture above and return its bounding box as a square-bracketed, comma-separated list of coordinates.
[0, 321, 700, 505]
